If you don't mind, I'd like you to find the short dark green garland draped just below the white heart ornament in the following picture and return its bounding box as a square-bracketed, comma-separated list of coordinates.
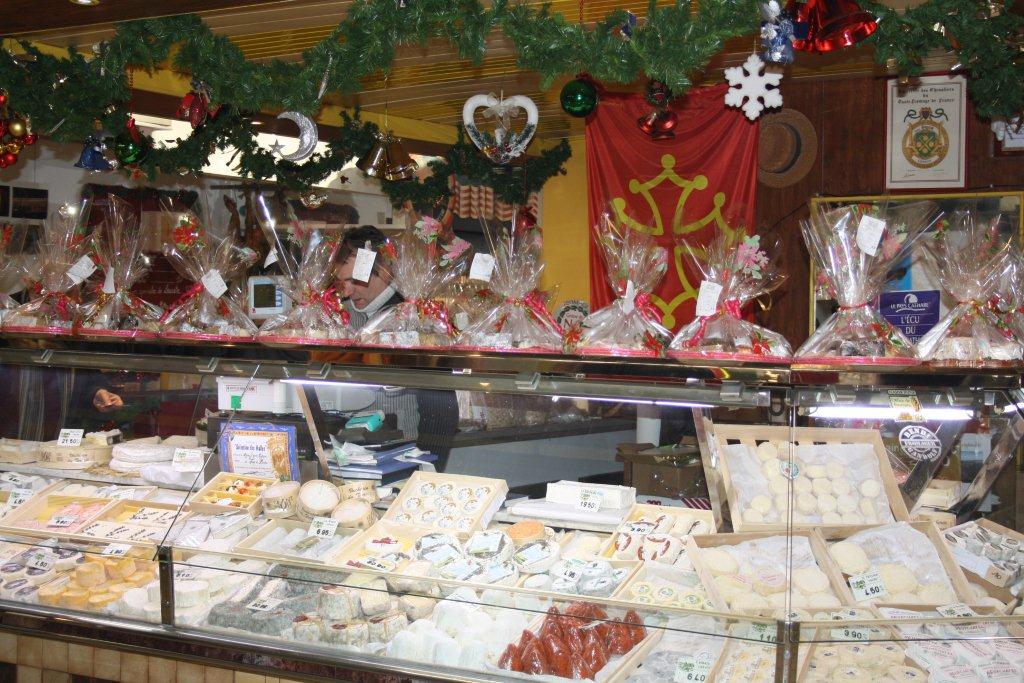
[381, 127, 572, 215]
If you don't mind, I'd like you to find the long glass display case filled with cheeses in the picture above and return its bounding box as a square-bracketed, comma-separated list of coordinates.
[0, 340, 1024, 682]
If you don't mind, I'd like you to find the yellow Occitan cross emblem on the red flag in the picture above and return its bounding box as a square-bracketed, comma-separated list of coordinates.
[611, 154, 736, 329]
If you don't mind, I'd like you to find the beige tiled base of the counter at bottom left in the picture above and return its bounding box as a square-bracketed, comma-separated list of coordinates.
[0, 632, 299, 683]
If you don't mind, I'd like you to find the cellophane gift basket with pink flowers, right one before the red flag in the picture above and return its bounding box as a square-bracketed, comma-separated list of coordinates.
[668, 227, 792, 362]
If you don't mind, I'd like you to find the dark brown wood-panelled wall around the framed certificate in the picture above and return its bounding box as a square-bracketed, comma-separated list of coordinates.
[758, 77, 1024, 348]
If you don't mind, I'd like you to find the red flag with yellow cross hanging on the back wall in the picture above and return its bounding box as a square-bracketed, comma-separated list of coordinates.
[587, 85, 758, 330]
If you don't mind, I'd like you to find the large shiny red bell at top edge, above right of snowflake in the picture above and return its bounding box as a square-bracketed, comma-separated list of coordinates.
[786, 0, 879, 52]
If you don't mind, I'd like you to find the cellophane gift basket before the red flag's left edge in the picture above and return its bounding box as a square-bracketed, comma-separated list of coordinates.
[566, 209, 672, 356]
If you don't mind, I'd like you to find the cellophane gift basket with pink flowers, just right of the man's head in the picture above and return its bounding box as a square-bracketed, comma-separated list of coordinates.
[356, 217, 470, 348]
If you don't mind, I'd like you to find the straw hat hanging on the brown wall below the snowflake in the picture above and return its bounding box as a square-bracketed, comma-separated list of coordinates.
[758, 109, 818, 187]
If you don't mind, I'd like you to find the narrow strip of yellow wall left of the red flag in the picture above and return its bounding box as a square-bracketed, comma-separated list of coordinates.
[541, 135, 590, 308]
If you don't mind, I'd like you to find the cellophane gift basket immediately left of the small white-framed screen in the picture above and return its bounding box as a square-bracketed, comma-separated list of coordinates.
[160, 200, 257, 342]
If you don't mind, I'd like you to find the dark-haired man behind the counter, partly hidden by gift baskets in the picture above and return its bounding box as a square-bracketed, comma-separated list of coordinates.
[335, 225, 459, 472]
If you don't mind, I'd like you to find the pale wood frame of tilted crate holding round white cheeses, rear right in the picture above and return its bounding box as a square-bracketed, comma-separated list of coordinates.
[709, 424, 910, 531]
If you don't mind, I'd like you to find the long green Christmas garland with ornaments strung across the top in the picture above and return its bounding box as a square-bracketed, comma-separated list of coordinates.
[0, 0, 1024, 187]
